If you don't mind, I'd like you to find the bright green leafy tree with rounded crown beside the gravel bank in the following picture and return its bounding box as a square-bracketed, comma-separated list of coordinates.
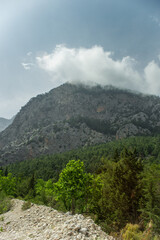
[54, 160, 91, 214]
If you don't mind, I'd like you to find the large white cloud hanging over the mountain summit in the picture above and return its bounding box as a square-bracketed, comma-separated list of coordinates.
[37, 45, 160, 94]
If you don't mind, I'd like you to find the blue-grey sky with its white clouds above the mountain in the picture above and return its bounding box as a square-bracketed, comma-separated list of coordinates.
[0, 0, 160, 118]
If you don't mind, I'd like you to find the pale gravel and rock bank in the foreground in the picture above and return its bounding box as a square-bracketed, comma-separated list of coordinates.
[0, 199, 113, 240]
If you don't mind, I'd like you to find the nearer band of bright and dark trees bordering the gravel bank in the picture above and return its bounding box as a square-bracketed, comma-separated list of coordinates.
[0, 147, 160, 239]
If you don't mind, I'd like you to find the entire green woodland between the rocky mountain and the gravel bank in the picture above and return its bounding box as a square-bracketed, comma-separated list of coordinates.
[0, 136, 160, 240]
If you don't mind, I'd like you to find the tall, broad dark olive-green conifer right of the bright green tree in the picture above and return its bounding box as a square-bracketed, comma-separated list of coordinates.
[102, 149, 143, 230]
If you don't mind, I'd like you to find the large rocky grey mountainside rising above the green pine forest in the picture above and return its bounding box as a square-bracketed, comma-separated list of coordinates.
[0, 84, 160, 165]
